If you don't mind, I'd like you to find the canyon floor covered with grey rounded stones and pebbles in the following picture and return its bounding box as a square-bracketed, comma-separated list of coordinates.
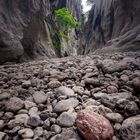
[0, 53, 140, 140]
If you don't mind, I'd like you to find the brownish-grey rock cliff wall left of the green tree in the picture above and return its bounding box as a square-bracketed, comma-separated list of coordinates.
[0, 0, 81, 63]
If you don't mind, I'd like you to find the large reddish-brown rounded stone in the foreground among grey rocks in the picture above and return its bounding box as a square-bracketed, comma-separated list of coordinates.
[76, 111, 114, 140]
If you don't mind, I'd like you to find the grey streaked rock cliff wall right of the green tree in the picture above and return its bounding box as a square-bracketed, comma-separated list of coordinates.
[79, 0, 140, 53]
